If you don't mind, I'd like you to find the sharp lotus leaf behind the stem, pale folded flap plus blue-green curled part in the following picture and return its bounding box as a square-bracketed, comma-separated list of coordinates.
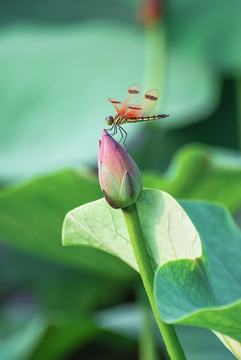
[63, 190, 241, 356]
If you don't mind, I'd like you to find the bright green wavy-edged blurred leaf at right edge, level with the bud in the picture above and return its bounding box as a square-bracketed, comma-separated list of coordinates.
[143, 144, 241, 212]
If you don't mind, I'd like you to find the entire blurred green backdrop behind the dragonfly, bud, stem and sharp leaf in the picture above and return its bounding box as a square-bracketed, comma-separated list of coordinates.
[0, 0, 241, 360]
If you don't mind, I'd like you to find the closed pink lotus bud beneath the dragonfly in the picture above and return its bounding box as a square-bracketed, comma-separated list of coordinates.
[98, 130, 142, 209]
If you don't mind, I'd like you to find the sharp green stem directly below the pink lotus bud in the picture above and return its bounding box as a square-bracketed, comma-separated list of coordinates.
[122, 204, 186, 360]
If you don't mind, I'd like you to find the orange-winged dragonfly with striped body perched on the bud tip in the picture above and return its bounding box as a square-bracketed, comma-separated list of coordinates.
[106, 85, 169, 147]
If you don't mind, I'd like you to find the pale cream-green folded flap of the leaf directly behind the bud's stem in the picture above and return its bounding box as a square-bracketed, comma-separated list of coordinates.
[63, 189, 201, 270]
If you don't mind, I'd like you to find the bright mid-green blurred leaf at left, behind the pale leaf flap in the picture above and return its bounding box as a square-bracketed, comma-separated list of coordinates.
[0, 171, 132, 280]
